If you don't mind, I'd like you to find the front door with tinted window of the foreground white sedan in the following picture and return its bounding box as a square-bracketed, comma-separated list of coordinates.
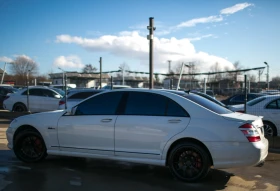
[58, 92, 123, 155]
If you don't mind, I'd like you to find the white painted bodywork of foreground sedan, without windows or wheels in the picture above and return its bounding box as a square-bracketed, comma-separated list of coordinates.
[7, 89, 268, 168]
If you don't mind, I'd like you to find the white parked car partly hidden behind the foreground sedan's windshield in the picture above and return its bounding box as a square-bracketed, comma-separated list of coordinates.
[58, 88, 104, 109]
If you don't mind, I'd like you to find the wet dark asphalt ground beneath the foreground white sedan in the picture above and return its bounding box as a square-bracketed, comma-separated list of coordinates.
[0, 119, 280, 191]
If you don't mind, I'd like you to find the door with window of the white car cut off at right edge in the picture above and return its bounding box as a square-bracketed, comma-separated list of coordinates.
[261, 99, 280, 128]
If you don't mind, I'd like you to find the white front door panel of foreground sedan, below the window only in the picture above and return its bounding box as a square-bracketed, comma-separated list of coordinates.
[58, 115, 117, 155]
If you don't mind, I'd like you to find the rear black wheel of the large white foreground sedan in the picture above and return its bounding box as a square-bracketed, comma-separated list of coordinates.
[168, 142, 211, 182]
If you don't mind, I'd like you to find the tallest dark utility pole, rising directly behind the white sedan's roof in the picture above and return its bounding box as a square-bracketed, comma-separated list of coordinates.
[147, 17, 156, 89]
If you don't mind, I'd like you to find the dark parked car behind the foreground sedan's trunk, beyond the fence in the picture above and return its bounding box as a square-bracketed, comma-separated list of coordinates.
[221, 93, 265, 105]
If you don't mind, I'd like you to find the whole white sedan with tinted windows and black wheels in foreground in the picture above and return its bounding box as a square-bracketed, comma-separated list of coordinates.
[6, 89, 268, 182]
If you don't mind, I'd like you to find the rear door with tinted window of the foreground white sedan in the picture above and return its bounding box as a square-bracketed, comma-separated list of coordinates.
[115, 92, 190, 159]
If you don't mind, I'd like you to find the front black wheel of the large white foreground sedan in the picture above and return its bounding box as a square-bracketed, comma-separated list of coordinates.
[13, 130, 47, 163]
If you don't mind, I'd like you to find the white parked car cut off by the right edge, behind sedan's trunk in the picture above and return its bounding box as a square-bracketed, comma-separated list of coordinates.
[230, 95, 280, 136]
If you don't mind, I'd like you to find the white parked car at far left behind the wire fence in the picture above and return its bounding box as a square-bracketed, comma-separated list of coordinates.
[3, 86, 62, 112]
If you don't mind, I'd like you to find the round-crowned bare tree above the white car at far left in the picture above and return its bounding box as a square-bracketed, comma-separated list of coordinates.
[9, 56, 38, 85]
